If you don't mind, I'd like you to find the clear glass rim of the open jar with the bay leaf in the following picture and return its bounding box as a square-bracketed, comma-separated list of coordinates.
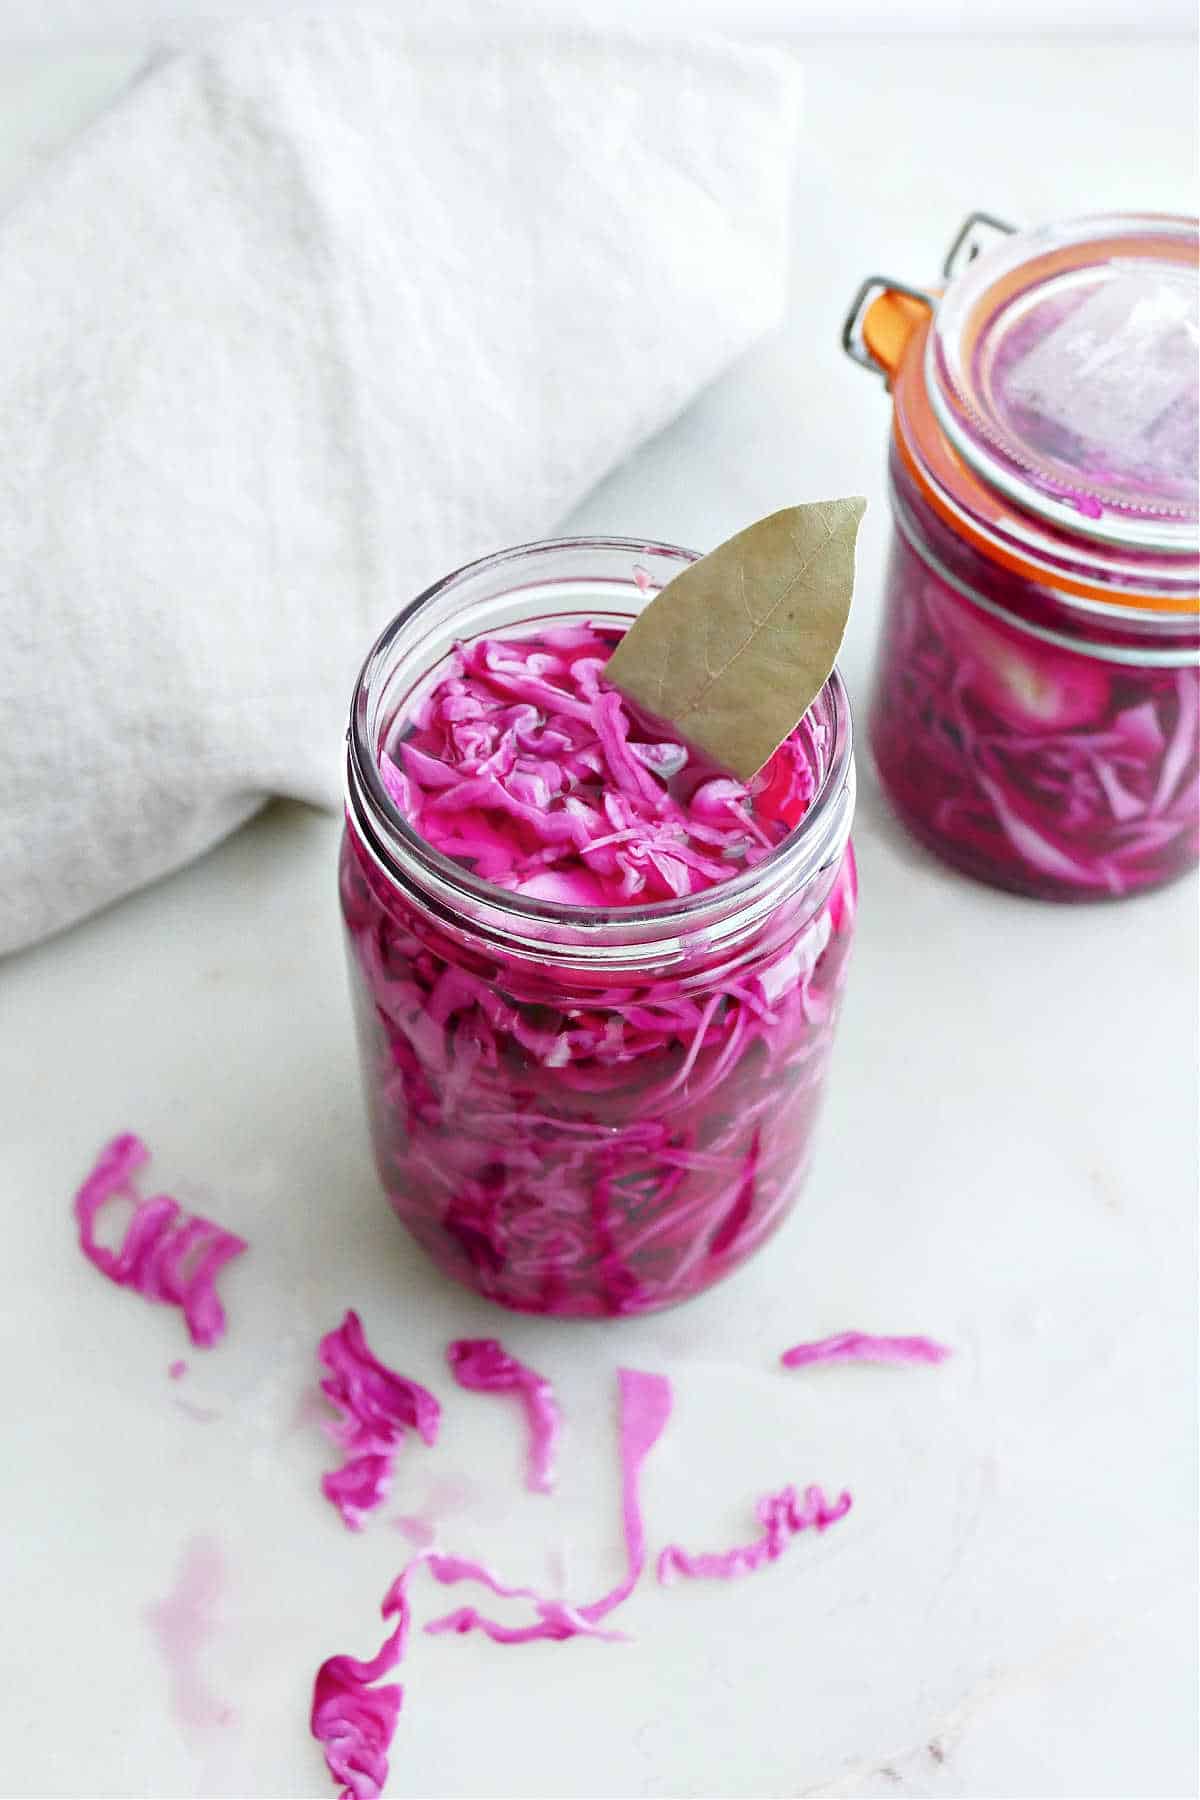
[345, 535, 855, 954]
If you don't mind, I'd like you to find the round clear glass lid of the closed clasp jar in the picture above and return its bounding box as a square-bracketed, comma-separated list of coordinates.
[925, 214, 1200, 554]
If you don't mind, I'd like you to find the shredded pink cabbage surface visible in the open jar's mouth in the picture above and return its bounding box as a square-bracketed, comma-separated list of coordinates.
[394, 625, 815, 905]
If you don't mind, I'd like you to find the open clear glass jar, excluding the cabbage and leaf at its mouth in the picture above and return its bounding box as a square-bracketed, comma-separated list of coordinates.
[340, 538, 856, 1318]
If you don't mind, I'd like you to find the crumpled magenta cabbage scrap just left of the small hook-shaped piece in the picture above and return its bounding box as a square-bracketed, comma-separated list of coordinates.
[317, 1312, 441, 1532]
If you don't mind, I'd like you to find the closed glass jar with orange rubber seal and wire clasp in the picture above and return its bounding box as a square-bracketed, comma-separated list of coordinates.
[844, 214, 1200, 900]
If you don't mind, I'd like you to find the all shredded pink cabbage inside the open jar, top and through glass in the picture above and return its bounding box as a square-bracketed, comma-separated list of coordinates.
[342, 625, 856, 1318]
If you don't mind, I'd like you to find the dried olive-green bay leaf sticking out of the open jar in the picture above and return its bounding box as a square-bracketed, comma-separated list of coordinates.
[604, 499, 867, 781]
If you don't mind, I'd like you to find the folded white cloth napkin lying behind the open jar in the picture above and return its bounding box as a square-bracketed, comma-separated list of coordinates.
[0, 13, 797, 950]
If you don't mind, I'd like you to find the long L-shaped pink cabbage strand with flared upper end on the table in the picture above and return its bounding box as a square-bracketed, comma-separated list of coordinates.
[425, 1368, 671, 1643]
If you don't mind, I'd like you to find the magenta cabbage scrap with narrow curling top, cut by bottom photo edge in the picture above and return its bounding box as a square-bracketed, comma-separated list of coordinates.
[309, 1564, 416, 1800]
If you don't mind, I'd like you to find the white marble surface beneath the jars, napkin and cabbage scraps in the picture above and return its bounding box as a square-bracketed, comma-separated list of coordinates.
[0, 34, 1196, 1796]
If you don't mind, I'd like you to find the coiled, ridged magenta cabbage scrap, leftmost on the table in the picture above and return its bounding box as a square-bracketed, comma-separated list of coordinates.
[76, 1132, 246, 1350]
